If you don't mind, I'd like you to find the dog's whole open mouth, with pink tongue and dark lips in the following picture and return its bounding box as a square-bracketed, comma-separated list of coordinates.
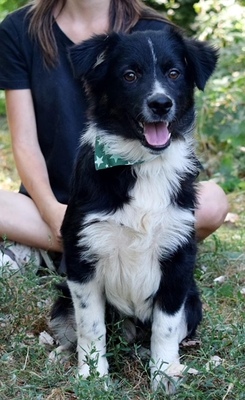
[140, 122, 171, 151]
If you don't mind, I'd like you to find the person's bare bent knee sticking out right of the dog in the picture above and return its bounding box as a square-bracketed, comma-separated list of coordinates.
[196, 181, 229, 241]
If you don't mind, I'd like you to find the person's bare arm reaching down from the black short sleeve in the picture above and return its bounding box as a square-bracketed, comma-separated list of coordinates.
[6, 89, 66, 247]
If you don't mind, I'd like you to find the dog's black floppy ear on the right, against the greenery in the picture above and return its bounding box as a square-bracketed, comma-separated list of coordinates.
[185, 39, 219, 90]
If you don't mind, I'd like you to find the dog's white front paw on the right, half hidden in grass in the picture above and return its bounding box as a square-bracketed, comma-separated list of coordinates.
[151, 362, 186, 394]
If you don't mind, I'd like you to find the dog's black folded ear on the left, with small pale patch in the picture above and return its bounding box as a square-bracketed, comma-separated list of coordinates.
[69, 33, 120, 79]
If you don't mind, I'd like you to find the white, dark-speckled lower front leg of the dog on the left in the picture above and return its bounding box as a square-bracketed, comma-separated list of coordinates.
[68, 280, 108, 378]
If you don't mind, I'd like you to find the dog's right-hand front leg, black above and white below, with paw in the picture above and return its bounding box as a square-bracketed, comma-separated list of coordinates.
[151, 240, 196, 393]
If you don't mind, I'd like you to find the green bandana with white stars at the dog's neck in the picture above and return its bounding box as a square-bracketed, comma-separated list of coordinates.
[94, 137, 141, 171]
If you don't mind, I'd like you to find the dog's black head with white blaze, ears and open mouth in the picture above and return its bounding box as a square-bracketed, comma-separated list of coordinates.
[70, 24, 218, 153]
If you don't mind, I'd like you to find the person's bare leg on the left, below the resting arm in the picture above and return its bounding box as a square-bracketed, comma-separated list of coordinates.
[0, 190, 62, 252]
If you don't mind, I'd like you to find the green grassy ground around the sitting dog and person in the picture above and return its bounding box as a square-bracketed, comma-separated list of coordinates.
[0, 121, 245, 400]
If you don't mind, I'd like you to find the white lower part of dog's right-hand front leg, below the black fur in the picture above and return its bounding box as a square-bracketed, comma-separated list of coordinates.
[150, 305, 187, 394]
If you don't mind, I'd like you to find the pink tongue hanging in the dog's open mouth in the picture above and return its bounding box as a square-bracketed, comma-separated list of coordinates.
[144, 122, 170, 146]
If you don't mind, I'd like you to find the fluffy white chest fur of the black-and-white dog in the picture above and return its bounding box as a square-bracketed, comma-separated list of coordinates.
[80, 155, 193, 320]
